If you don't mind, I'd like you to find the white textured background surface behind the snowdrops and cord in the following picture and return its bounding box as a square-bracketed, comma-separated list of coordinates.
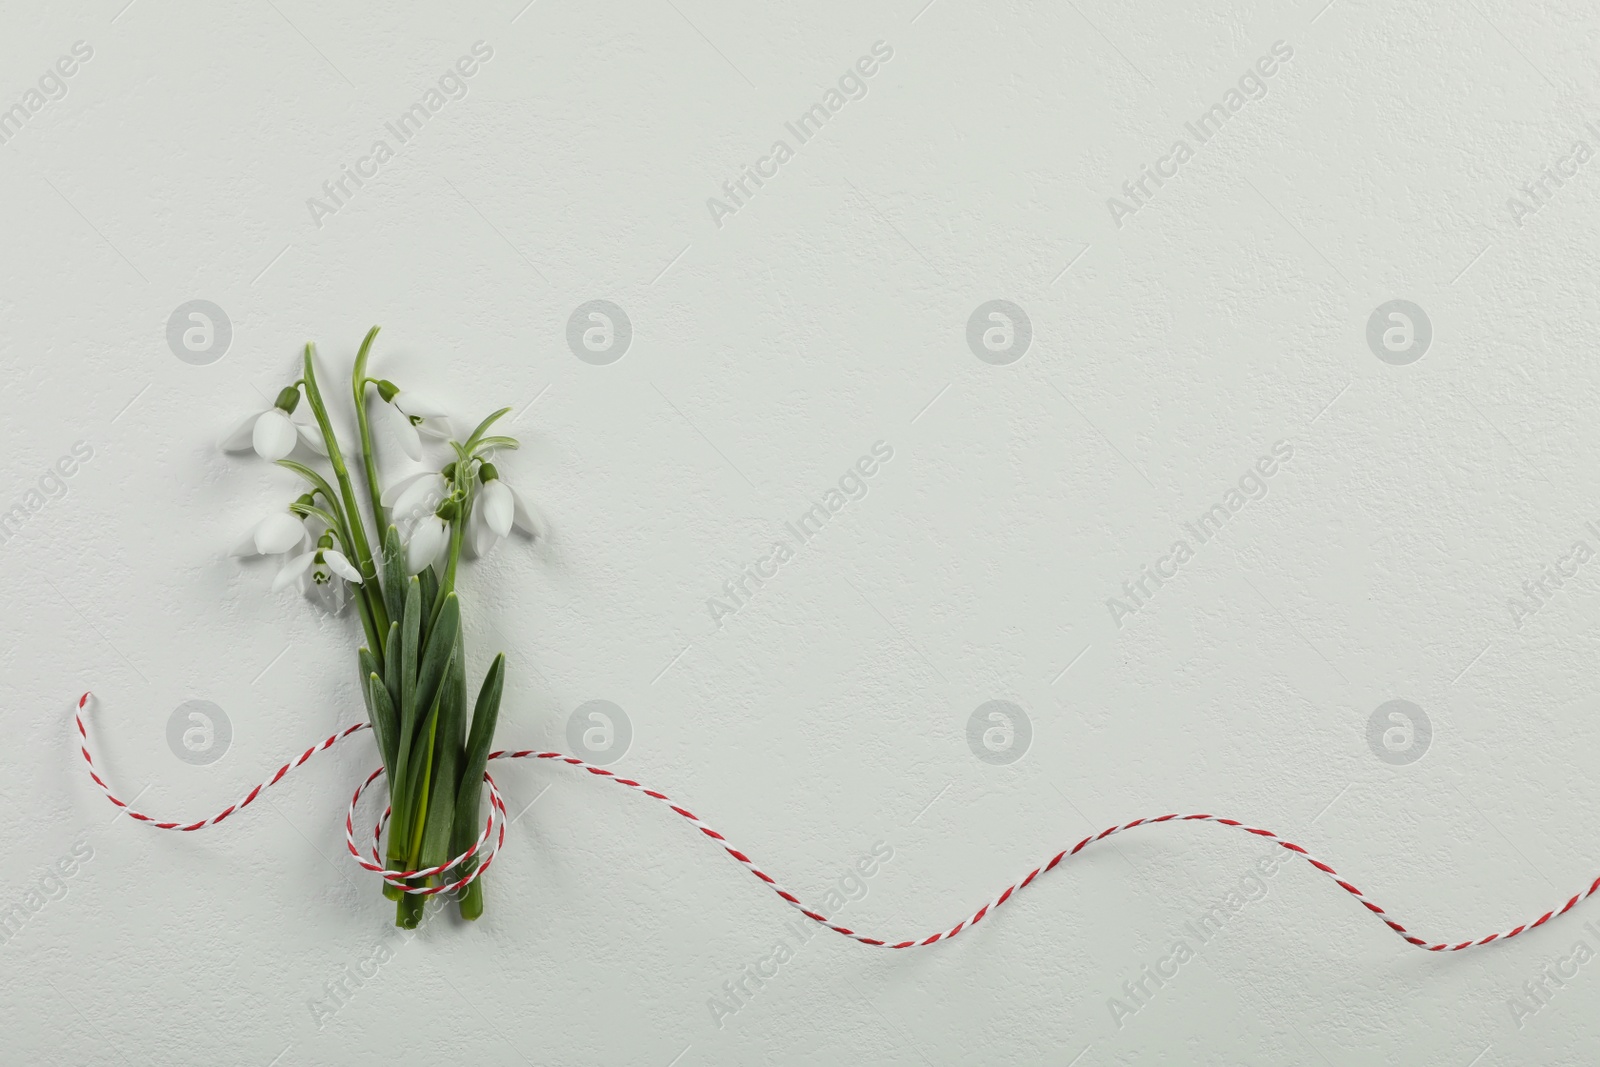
[0, 0, 1600, 1067]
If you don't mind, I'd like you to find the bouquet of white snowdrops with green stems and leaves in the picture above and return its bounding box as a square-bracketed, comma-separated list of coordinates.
[222, 326, 538, 928]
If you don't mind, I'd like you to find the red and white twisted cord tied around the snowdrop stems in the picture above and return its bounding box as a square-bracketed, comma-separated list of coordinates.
[74, 693, 1600, 952]
